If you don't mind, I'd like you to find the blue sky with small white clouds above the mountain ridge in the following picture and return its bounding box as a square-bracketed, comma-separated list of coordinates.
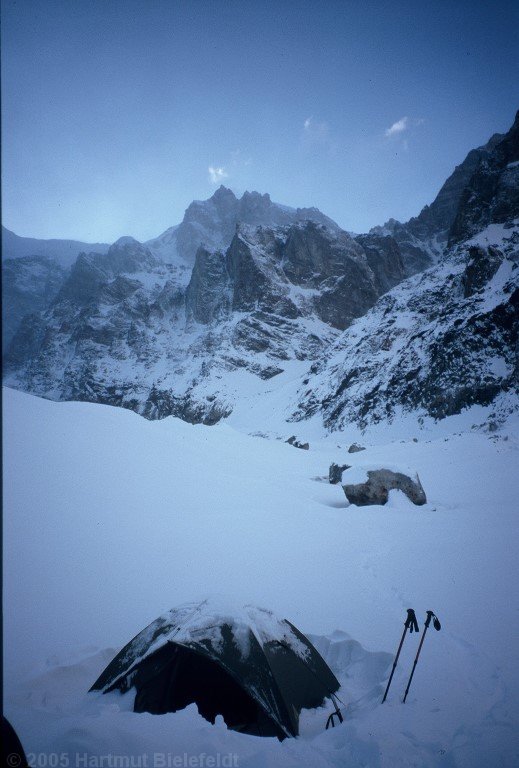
[1, 0, 519, 242]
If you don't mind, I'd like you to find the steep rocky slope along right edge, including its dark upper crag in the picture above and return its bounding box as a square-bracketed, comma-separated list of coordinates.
[293, 112, 519, 429]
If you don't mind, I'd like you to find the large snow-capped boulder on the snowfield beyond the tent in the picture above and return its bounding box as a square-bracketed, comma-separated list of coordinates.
[342, 469, 427, 507]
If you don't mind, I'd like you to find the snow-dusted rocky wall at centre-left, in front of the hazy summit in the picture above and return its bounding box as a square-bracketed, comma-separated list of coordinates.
[4, 220, 403, 423]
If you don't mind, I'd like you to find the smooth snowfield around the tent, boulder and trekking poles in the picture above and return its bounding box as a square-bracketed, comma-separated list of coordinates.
[3, 390, 519, 768]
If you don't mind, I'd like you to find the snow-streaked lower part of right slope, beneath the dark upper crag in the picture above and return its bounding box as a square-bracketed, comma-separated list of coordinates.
[294, 238, 519, 430]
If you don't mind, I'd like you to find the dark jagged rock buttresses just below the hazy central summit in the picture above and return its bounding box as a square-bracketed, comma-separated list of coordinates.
[186, 222, 404, 330]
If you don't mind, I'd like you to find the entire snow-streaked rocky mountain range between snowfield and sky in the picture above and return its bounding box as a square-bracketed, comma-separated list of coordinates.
[4, 111, 519, 429]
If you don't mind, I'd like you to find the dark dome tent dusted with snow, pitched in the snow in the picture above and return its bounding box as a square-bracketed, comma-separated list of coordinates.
[90, 600, 339, 739]
